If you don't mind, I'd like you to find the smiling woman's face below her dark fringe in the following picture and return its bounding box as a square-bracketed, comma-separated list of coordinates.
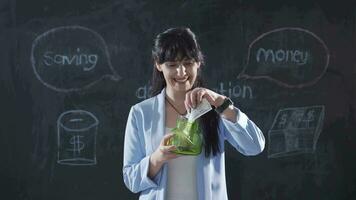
[155, 59, 200, 92]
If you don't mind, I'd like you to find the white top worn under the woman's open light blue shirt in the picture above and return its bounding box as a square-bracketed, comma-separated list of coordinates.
[166, 127, 198, 200]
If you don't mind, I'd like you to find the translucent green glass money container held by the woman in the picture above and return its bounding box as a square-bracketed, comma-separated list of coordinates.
[168, 117, 203, 155]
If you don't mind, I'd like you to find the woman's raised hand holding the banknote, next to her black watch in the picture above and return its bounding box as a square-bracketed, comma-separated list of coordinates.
[184, 87, 226, 110]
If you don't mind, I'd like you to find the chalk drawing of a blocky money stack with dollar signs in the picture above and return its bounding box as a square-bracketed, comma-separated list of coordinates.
[268, 105, 325, 158]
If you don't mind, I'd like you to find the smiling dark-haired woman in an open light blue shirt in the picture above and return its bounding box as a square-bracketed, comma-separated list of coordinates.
[123, 28, 265, 200]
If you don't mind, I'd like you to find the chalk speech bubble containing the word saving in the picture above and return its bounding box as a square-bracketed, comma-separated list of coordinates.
[31, 26, 121, 92]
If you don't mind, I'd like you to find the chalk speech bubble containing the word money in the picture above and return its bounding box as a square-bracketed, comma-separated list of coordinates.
[238, 27, 330, 88]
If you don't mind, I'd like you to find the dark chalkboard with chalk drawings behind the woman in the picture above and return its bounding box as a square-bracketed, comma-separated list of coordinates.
[0, 0, 356, 200]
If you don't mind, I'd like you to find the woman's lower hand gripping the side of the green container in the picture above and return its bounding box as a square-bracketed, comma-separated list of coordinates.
[148, 133, 179, 178]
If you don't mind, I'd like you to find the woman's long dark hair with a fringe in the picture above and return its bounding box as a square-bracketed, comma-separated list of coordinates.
[150, 27, 220, 157]
